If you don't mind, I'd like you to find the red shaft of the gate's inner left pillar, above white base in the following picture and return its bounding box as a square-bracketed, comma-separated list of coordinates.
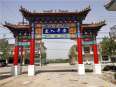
[30, 39, 35, 65]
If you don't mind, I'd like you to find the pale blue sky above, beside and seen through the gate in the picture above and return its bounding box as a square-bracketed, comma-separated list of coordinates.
[0, 0, 116, 56]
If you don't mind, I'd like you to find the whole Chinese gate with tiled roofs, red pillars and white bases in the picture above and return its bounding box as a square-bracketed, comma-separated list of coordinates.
[4, 7, 105, 76]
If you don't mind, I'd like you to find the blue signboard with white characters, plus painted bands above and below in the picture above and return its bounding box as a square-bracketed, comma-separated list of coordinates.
[42, 24, 70, 39]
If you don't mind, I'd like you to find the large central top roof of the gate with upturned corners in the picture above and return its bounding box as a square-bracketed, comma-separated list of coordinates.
[19, 7, 91, 20]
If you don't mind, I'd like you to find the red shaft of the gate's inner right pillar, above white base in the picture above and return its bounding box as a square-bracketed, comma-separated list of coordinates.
[77, 37, 83, 64]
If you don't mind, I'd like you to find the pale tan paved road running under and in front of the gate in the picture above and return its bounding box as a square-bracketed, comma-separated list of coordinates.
[0, 64, 116, 87]
